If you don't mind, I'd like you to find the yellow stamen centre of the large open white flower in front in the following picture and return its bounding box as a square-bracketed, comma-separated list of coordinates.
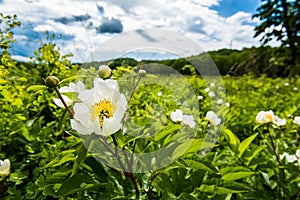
[91, 99, 116, 128]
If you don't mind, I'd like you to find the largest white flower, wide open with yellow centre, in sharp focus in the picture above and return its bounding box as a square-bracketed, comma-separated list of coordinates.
[71, 78, 127, 136]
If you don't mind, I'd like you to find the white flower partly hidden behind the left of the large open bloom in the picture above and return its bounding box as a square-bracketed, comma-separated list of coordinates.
[53, 81, 84, 108]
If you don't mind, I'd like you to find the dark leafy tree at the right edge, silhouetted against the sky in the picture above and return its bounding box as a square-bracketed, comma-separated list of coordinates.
[252, 0, 300, 73]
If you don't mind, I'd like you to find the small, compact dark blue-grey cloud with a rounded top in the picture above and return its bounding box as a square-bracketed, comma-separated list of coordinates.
[96, 18, 123, 33]
